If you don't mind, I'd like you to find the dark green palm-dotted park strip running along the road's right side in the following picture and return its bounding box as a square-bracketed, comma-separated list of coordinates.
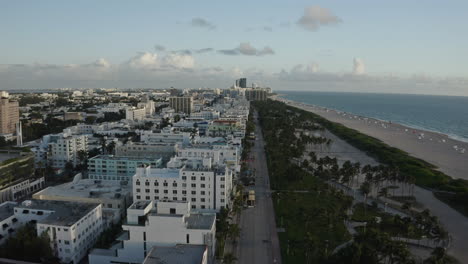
[255, 100, 352, 263]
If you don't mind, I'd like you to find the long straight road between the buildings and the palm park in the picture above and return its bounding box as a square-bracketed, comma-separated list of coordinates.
[237, 112, 281, 264]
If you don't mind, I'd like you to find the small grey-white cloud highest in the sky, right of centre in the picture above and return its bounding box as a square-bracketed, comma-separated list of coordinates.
[297, 6, 342, 31]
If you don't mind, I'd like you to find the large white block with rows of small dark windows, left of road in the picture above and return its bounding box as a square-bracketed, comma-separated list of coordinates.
[133, 158, 232, 211]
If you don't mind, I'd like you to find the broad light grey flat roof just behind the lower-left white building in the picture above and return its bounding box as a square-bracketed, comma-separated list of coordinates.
[34, 179, 132, 199]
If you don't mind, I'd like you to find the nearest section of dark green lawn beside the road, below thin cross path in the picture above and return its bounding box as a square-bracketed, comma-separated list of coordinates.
[273, 191, 351, 263]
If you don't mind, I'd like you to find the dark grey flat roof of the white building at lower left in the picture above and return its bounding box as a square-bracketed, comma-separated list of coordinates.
[15, 200, 99, 226]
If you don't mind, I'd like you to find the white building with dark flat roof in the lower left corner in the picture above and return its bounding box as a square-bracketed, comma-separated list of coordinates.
[5, 200, 103, 263]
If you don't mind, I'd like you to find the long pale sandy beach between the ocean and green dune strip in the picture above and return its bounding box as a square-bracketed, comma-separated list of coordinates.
[275, 97, 468, 180]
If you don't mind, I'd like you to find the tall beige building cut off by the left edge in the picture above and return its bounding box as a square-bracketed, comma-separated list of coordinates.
[0, 92, 19, 134]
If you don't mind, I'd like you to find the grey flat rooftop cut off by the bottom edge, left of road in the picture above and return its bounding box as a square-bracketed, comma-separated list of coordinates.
[143, 244, 207, 264]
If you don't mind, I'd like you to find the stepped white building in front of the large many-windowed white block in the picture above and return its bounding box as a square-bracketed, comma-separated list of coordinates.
[89, 201, 216, 264]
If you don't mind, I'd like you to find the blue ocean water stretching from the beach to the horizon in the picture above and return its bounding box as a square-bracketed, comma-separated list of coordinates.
[278, 91, 468, 142]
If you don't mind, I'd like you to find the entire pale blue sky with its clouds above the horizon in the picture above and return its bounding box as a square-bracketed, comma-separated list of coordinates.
[0, 0, 468, 96]
